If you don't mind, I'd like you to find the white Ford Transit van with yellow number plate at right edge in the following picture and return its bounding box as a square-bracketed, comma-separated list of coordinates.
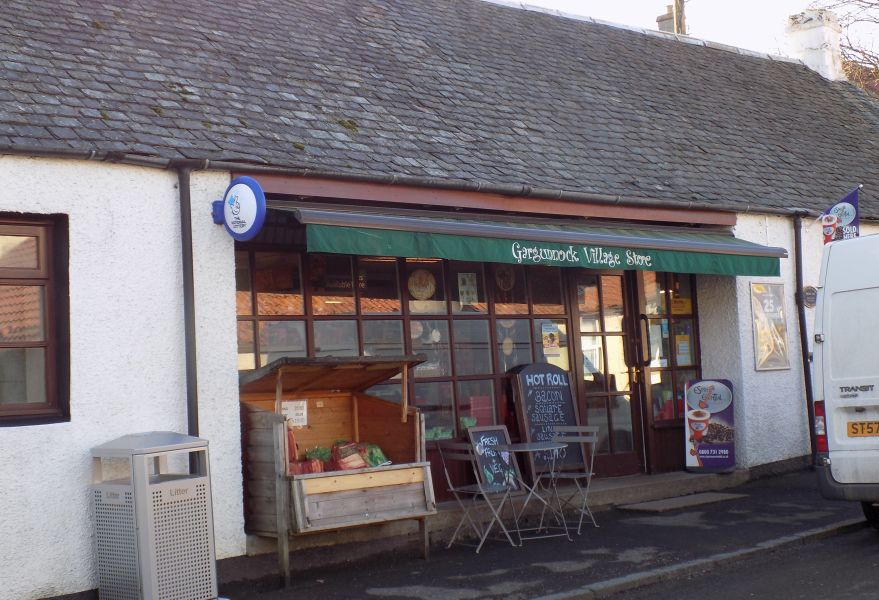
[812, 235, 879, 528]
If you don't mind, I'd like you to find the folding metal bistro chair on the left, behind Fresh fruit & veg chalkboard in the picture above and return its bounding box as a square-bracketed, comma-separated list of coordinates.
[437, 441, 519, 553]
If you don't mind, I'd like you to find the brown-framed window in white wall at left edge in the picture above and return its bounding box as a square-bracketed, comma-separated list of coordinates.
[0, 220, 69, 425]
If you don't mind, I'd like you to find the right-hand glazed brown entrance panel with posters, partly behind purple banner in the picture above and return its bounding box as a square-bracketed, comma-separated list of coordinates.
[630, 271, 701, 473]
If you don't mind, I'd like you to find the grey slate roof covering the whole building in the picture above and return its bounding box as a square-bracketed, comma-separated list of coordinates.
[0, 0, 879, 217]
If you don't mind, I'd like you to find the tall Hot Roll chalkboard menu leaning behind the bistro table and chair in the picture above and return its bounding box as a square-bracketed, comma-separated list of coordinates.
[512, 363, 584, 476]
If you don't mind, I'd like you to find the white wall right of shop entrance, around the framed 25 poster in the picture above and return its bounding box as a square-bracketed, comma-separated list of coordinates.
[697, 215, 879, 467]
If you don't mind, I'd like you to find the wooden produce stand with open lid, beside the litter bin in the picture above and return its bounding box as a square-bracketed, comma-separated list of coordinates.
[239, 356, 436, 586]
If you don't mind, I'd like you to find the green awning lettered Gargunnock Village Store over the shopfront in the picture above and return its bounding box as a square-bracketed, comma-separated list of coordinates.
[270, 202, 787, 276]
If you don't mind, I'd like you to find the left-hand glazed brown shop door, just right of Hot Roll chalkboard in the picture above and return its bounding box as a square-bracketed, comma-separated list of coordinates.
[571, 270, 644, 477]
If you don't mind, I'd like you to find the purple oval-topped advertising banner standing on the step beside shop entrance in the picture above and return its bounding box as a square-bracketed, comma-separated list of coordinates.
[684, 379, 736, 473]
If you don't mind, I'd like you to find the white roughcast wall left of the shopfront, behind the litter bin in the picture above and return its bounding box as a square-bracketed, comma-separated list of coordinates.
[0, 156, 244, 600]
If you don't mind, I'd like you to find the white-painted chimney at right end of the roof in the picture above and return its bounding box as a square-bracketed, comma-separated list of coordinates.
[787, 9, 846, 81]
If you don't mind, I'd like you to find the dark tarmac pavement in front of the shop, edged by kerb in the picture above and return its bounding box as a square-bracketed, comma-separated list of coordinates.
[220, 469, 879, 600]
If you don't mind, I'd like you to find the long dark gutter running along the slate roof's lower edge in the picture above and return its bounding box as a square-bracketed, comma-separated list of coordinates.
[0, 145, 818, 217]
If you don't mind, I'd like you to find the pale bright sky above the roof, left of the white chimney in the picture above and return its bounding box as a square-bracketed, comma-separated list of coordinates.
[523, 0, 828, 55]
